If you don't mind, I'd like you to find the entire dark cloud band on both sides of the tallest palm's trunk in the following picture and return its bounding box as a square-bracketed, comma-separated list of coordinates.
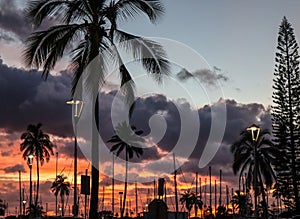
[0, 57, 271, 187]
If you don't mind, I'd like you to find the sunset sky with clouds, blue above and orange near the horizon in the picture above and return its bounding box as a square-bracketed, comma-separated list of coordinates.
[0, 0, 300, 216]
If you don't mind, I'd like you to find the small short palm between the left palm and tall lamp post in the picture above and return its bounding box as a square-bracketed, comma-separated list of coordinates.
[51, 174, 71, 216]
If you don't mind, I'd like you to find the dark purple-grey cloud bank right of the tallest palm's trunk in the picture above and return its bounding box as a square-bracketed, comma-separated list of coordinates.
[100, 89, 271, 185]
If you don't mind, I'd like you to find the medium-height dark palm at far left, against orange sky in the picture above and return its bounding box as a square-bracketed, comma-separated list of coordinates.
[20, 123, 54, 214]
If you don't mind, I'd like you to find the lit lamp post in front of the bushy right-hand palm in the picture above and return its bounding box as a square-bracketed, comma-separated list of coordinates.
[247, 124, 260, 218]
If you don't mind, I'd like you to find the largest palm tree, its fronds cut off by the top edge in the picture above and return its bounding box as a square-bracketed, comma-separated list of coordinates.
[24, 0, 169, 218]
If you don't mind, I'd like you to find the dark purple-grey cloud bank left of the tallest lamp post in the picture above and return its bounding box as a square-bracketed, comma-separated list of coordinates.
[0, 61, 73, 136]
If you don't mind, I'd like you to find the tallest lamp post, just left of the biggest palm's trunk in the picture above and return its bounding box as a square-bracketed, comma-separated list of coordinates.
[67, 100, 83, 216]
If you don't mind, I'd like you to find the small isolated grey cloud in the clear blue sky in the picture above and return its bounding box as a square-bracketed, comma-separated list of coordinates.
[177, 66, 229, 87]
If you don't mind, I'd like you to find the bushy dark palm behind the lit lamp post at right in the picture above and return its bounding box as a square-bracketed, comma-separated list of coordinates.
[231, 129, 279, 217]
